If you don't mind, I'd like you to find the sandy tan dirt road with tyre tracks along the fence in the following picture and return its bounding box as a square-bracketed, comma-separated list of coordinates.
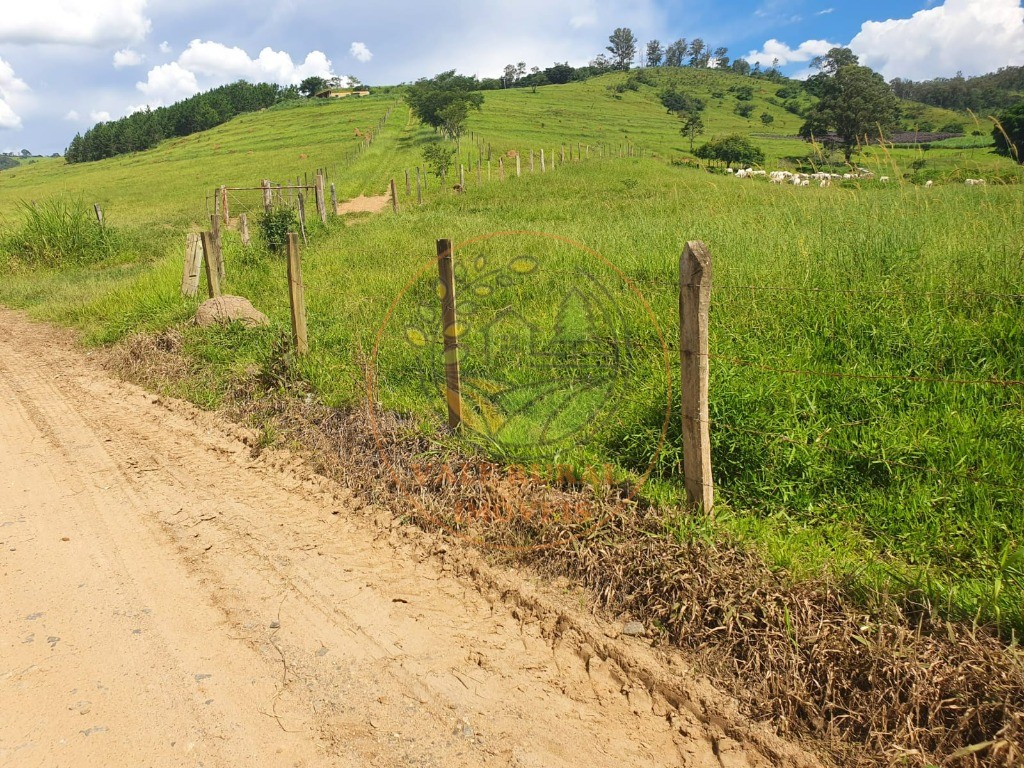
[0, 309, 813, 768]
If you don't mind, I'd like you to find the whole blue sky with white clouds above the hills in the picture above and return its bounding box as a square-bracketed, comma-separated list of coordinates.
[0, 0, 1024, 154]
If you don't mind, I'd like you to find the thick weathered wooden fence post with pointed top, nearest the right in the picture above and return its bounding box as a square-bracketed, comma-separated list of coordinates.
[679, 241, 715, 514]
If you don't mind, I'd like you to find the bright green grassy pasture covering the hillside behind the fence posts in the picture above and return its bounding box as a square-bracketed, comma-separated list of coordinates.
[0, 73, 1024, 633]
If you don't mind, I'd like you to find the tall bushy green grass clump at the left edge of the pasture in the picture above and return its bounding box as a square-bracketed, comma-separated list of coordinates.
[0, 197, 123, 267]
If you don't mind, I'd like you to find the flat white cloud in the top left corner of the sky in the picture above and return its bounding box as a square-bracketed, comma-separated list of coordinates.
[0, 0, 151, 47]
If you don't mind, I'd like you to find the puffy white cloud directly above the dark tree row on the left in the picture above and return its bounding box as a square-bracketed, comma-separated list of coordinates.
[135, 40, 335, 106]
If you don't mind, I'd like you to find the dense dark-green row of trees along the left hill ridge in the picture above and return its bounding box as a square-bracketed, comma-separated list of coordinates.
[65, 80, 299, 163]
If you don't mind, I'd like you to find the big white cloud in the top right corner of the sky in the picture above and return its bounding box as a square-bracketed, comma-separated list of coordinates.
[850, 0, 1024, 80]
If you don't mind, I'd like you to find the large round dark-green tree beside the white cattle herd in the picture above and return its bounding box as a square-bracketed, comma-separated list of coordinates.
[800, 60, 900, 163]
